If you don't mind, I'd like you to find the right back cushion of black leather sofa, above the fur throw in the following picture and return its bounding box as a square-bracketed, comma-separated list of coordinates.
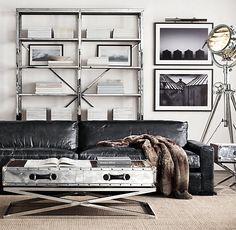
[79, 120, 188, 151]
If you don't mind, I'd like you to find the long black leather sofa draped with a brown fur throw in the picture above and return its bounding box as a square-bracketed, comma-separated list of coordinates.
[0, 120, 214, 195]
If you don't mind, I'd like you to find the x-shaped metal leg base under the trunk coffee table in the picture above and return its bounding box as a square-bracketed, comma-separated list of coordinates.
[4, 188, 155, 218]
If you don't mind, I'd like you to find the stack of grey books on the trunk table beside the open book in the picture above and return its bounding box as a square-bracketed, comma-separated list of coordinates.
[97, 157, 131, 168]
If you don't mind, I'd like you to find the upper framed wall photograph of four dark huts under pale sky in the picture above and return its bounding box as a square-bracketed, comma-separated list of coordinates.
[154, 23, 213, 65]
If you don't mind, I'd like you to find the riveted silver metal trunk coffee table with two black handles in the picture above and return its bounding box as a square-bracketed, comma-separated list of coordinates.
[3, 160, 156, 218]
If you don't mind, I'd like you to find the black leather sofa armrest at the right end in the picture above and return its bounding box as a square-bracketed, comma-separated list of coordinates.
[184, 140, 214, 195]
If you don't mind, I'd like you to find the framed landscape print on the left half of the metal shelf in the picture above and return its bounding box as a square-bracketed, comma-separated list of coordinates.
[29, 44, 63, 66]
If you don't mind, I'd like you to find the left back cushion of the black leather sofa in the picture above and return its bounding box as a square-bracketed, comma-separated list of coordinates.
[0, 121, 78, 150]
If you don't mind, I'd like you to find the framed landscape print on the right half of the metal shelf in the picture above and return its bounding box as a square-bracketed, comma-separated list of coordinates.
[97, 45, 132, 66]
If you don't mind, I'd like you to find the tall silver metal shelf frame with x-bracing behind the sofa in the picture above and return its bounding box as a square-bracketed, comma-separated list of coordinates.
[16, 8, 143, 120]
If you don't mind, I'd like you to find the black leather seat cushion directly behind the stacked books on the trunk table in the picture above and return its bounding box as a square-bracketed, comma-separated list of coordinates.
[80, 147, 145, 160]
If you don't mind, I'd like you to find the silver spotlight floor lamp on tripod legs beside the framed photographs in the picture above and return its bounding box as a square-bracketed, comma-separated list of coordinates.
[201, 24, 236, 143]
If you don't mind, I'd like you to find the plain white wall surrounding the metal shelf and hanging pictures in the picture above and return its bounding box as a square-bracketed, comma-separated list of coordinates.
[0, 0, 236, 142]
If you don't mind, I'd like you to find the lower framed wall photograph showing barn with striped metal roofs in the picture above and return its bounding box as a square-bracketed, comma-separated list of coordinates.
[154, 69, 213, 111]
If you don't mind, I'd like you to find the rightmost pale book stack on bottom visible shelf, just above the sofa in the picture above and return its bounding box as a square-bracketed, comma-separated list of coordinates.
[112, 107, 136, 120]
